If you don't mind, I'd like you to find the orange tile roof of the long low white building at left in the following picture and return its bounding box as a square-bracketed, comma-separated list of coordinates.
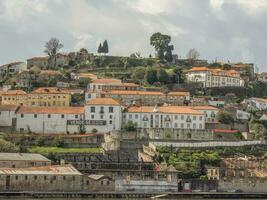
[17, 106, 84, 114]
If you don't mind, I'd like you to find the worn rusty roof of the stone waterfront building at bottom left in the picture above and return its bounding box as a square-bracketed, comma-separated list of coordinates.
[0, 165, 82, 176]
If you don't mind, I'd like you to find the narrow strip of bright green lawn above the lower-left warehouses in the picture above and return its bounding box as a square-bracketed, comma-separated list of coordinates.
[28, 147, 102, 154]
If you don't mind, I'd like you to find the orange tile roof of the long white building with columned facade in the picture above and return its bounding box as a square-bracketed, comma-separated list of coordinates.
[128, 106, 203, 115]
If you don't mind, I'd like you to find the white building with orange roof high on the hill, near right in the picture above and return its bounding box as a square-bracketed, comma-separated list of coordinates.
[186, 67, 244, 88]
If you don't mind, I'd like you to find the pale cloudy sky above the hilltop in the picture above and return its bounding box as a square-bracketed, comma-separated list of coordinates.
[0, 0, 267, 71]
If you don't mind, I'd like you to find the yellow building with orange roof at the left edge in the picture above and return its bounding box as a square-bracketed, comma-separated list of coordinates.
[0, 87, 71, 107]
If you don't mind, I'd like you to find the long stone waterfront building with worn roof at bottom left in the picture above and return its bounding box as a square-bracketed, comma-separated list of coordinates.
[0, 165, 83, 192]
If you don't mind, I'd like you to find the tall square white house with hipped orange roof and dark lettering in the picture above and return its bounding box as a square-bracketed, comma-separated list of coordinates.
[84, 98, 122, 133]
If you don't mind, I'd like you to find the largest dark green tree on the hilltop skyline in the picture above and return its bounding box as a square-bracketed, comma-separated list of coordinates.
[150, 32, 171, 60]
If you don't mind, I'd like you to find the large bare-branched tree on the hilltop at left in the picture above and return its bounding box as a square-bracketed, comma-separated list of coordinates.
[44, 38, 63, 68]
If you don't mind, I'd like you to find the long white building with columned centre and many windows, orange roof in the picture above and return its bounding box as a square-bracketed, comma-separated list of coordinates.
[125, 106, 205, 129]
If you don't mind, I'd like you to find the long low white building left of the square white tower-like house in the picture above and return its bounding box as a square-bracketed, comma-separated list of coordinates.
[16, 106, 84, 134]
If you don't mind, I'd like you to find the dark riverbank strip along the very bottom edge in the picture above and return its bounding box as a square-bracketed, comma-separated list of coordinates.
[0, 191, 267, 199]
